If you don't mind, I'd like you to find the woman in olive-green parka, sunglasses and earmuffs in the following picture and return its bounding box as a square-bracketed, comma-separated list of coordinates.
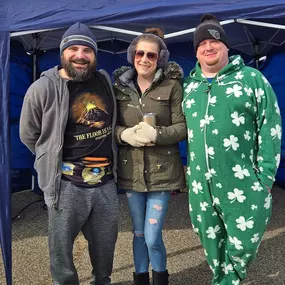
[114, 28, 187, 285]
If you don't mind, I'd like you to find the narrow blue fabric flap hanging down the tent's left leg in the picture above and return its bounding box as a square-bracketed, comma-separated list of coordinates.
[0, 32, 12, 285]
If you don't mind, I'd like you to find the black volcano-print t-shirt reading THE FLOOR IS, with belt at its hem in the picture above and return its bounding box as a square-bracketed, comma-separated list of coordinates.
[62, 73, 114, 187]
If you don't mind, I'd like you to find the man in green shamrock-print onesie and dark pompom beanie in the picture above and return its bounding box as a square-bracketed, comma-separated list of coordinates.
[182, 14, 281, 285]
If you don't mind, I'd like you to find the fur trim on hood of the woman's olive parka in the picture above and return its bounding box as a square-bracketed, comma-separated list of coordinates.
[113, 61, 184, 80]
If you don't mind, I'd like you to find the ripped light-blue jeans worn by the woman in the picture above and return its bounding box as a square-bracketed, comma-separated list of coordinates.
[126, 190, 171, 273]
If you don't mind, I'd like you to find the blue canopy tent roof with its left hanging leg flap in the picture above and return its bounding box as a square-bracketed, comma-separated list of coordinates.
[0, 0, 285, 285]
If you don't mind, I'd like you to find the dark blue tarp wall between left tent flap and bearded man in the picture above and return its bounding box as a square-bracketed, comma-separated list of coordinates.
[9, 41, 34, 193]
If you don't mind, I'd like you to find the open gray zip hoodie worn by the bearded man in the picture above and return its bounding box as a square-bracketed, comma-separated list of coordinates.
[20, 66, 117, 208]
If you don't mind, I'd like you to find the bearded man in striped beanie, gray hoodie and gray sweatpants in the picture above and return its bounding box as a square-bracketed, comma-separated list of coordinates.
[20, 23, 119, 285]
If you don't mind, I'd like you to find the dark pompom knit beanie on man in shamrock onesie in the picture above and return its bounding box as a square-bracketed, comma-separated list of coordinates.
[193, 14, 229, 52]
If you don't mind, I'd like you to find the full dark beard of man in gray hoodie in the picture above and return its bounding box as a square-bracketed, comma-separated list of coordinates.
[61, 57, 96, 82]
